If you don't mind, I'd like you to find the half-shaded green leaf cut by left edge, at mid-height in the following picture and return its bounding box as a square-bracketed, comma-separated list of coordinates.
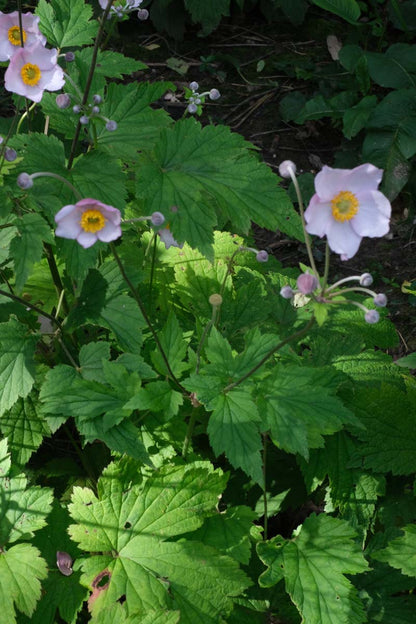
[0, 318, 37, 415]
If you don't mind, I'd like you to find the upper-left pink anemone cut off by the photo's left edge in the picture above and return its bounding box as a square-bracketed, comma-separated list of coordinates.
[0, 11, 46, 61]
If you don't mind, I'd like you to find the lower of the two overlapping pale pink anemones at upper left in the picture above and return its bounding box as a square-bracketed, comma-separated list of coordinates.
[4, 41, 65, 102]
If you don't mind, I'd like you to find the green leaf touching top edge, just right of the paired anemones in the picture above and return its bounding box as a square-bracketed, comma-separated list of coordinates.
[35, 0, 98, 49]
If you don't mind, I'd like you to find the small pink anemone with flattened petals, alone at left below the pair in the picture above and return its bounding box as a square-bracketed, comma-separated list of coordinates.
[55, 198, 121, 249]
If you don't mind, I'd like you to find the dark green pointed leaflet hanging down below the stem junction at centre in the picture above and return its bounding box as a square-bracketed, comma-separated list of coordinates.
[208, 389, 264, 483]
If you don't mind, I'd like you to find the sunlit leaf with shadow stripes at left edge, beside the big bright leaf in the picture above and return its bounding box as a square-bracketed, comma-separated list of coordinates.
[0, 442, 52, 544]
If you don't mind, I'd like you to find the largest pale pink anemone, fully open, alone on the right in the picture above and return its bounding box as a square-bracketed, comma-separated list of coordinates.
[305, 163, 391, 260]
